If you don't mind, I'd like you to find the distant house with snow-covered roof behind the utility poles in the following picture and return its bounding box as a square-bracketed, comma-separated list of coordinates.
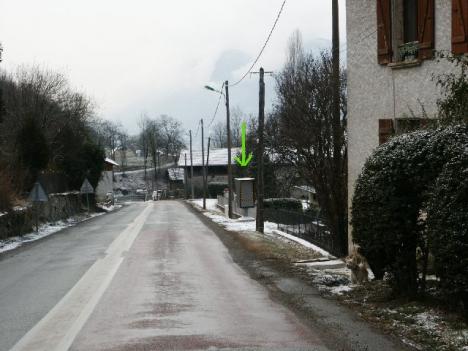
[179, 148, 240, 187]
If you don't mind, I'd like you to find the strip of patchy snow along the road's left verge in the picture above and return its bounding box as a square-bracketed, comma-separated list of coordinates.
[0, 212, 105, 253]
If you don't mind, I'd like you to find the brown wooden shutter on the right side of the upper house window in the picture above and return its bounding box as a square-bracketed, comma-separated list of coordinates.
[417, 0, 435, 60]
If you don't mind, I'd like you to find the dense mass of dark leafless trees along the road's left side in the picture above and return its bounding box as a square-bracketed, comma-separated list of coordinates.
[0, 68, 104, 210]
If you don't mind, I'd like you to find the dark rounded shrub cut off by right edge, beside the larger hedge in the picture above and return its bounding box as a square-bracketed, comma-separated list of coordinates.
[427, 155, 468, 317]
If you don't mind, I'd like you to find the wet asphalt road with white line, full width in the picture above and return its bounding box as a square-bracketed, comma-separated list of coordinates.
[0, 201, 327, 351]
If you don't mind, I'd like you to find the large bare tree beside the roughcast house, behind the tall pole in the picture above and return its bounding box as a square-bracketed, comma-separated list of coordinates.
[272, 36, 347, 254]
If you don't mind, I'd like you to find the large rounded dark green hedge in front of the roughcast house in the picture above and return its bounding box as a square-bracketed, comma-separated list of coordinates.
[351, 126, 468, 295]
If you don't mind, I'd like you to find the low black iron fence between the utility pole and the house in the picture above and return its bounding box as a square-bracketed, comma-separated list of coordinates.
[265, 208, 341, 257]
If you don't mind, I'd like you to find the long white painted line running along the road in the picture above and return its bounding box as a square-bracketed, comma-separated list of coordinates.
[10, 203, 153, 351]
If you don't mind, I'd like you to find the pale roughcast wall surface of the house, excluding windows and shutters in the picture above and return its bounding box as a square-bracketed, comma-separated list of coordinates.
[346, 0, 458, 250]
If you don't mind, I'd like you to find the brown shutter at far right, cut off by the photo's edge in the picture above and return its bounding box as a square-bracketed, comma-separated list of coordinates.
[452, 0, 468, 54]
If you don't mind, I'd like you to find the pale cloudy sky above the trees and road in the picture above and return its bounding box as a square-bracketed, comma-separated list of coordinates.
[0, 0, 346, 139]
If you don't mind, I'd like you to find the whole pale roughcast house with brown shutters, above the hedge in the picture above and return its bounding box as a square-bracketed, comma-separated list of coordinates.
[346, 0, 468, 249]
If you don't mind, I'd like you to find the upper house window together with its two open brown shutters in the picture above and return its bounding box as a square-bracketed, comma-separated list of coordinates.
[376, 0, 436, 64]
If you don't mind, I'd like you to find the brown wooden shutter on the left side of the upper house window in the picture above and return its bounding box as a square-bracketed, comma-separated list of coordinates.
[377, 0, 392, 65]
